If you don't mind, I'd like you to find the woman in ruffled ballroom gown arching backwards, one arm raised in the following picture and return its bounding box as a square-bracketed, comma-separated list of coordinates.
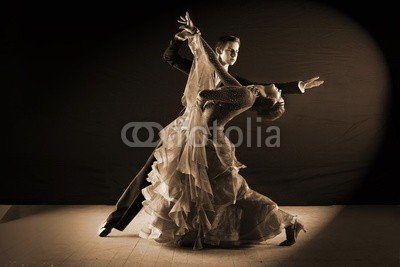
[139, 15, 305, 249]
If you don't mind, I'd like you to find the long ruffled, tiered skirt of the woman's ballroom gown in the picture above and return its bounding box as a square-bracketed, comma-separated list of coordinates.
[139, 107, 296, 249]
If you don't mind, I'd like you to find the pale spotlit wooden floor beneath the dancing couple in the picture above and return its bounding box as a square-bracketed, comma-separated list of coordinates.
[0, 206, 400, 267]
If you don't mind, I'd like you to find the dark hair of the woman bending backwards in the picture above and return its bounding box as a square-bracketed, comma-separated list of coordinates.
[250, 97, 285, 121]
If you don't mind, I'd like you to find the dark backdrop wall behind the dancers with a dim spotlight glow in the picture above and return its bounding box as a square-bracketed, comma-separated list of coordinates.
[0, 1, 400, 205]
